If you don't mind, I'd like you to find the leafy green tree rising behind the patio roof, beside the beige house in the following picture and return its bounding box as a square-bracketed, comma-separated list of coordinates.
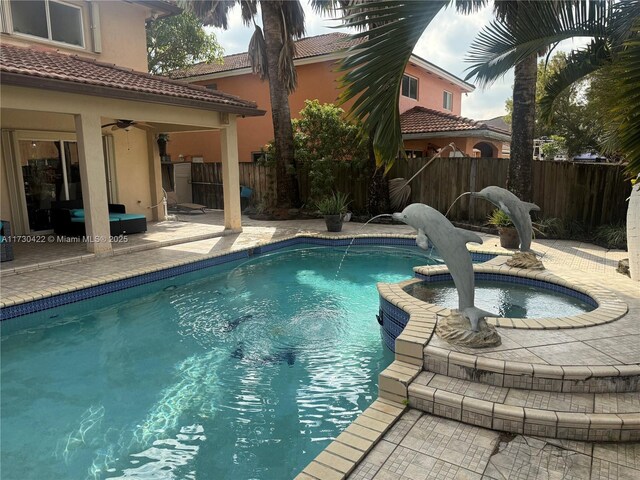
[146, 12, 222, 75]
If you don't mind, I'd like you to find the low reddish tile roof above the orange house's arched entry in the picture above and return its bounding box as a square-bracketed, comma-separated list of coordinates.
[400, 107, 510, 135]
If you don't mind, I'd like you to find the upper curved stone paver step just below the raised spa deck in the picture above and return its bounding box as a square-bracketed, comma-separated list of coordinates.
[424, 345, 640, 393]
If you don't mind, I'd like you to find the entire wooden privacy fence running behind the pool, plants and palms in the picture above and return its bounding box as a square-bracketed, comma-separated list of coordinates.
[191, 157, 631, 227]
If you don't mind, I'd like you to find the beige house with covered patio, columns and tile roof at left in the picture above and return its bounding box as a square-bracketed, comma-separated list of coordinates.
[0, 0, 264, 252]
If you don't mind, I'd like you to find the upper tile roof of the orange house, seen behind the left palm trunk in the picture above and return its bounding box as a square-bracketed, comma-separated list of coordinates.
[171, 32, 363, 78]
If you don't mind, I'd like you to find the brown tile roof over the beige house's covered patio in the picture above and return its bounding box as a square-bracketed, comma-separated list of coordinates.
[0, 44, 264, 115]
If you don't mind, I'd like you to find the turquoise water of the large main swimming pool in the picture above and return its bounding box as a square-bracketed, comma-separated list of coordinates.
[1, 246, 438, 480]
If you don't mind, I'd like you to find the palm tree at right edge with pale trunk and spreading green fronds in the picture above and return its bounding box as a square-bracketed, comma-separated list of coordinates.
[464, 0, 640, 281]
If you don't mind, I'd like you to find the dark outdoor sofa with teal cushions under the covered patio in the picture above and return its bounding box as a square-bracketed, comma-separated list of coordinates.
[51, 200, 147, 237]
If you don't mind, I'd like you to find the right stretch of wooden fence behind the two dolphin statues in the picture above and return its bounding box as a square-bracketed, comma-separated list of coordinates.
[389, 157, 631, 227]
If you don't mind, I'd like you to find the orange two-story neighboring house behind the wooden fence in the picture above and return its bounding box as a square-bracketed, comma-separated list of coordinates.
[168, 33, 510, 162]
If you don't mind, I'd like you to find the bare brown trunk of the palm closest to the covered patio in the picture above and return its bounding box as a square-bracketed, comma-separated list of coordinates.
[260, 2, 300, 208]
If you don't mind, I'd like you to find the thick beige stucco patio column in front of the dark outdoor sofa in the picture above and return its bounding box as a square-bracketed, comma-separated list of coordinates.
[74, 114, 111, 254]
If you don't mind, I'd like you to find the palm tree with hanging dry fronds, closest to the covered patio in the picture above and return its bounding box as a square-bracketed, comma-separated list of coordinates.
[181, 0, 330, 207]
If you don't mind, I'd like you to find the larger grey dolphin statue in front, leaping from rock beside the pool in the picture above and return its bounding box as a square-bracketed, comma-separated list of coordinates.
[392, 203, 497, 332]
